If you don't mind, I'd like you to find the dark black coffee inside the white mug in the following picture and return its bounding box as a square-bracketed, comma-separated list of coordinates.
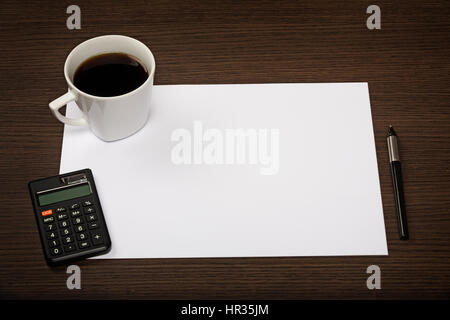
[73, 53, 148, 97]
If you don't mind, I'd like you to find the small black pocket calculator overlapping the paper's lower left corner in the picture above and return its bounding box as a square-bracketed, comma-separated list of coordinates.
[28, 169, 111, 265]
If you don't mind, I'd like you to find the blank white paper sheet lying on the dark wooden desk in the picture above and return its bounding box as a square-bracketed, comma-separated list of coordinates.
[60, 83, 387, 258]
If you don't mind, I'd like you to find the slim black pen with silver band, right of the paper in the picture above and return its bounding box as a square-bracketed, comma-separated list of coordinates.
[387, 126, 408, 240]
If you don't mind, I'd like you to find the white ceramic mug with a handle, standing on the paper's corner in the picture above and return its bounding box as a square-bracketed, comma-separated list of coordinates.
[49, 35, 156, 141]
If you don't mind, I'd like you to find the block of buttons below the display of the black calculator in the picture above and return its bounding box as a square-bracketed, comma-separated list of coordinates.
[41, 200, 104, 256]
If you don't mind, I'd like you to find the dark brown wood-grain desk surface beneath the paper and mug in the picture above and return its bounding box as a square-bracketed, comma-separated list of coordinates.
[0, 0, 450, 299]
